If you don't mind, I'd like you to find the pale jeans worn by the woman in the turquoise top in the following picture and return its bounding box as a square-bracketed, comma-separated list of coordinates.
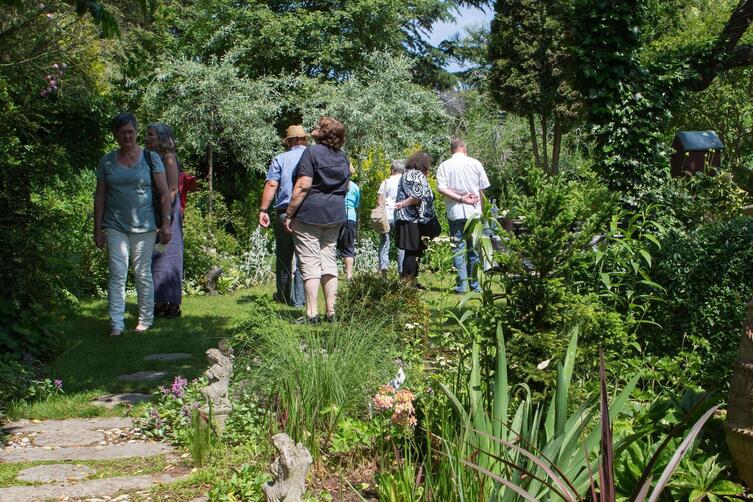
[104, 228, 157, 331]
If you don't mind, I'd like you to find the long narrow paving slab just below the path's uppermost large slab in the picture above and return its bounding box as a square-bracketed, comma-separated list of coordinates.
[0, 441, 173, 462]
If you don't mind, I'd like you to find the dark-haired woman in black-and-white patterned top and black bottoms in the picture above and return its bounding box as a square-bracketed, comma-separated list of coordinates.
[395, 151, 434, 289]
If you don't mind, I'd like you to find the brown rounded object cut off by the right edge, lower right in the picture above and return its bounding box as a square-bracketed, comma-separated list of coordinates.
[724, 300, 753, 488]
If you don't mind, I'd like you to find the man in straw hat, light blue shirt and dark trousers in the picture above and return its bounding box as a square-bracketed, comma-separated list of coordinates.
[259, 125, 308, 307]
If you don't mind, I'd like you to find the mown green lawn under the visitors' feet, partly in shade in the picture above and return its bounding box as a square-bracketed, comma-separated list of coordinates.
[8, 268, 470, 420]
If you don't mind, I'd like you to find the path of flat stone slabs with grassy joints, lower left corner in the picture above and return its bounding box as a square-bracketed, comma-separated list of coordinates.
[0, 418, 187, 502]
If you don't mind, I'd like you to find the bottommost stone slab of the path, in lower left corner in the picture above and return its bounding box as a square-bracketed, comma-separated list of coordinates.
[0, 474, 186, 502]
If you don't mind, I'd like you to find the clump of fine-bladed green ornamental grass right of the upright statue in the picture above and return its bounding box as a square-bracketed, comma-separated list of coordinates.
[249, 315, 397, 457]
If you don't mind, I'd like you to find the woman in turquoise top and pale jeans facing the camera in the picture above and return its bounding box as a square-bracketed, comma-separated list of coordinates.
[94, 113, 172, 336]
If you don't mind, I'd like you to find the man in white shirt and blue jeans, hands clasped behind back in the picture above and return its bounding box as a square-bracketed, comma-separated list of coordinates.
[437, 138, 489, 294]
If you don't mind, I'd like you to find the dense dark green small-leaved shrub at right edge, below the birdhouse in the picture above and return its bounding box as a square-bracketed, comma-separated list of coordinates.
[640, 217, 753, 387]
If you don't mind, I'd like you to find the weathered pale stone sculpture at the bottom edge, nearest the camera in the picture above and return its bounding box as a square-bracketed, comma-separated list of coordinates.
[263, 433, 313, 502]
